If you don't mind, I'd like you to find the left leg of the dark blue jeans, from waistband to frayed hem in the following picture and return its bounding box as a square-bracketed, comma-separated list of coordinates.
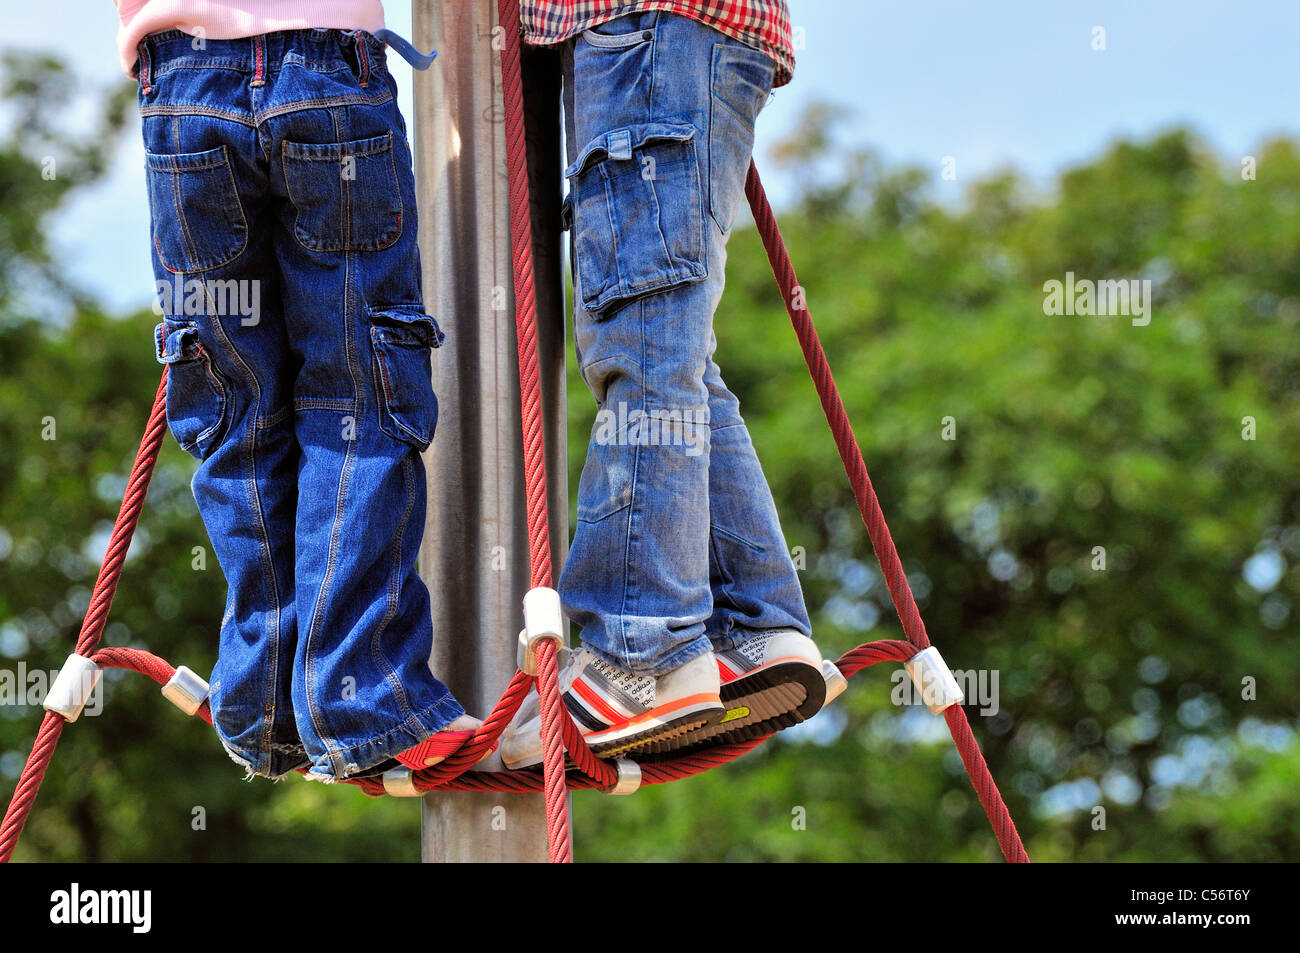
[140, 35, 307, 777]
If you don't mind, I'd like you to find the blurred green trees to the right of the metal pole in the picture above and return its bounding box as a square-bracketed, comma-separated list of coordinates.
[576, 111, 1300, 859]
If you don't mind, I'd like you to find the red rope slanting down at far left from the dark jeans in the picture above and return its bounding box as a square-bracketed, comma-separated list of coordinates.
[0, 368, 170, 863]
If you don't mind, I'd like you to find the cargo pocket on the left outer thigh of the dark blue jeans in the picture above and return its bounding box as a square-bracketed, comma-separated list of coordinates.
[153, 319, 228, 460]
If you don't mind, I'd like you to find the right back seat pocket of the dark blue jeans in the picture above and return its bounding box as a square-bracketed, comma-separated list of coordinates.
[281, 133, 402, 251]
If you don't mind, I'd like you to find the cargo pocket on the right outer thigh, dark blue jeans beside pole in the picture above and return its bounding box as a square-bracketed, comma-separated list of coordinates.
[371, 308, 445, 451]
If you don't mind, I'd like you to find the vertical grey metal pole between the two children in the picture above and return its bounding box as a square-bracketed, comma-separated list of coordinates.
[412, 0, 568, 862]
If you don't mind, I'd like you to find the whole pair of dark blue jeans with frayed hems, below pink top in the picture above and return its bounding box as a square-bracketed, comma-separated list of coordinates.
[139, 30, 463, 780]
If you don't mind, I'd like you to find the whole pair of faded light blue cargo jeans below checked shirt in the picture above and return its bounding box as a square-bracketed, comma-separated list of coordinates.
[559, 12, 811, 675]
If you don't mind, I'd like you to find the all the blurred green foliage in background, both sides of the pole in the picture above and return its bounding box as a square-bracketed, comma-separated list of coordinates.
[0, 61, 1300, 861]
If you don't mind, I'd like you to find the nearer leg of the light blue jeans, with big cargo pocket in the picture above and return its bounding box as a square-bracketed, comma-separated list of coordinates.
[559, 26, 722, 675]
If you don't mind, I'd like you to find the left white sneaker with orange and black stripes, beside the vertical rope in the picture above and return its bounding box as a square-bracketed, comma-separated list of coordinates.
[501, 647, 725, 770]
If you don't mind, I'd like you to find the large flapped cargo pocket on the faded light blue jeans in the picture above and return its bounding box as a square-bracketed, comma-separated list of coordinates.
[564, 122, 707, 317]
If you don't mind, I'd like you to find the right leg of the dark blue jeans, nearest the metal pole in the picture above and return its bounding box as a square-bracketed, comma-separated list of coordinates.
[264, 31, 464, 780]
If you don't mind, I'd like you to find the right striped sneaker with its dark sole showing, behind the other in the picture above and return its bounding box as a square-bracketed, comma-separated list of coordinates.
[679, 629, 826, 753]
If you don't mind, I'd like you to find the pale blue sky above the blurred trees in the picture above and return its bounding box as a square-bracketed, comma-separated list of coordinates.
[0, 0, 1300, 309]
